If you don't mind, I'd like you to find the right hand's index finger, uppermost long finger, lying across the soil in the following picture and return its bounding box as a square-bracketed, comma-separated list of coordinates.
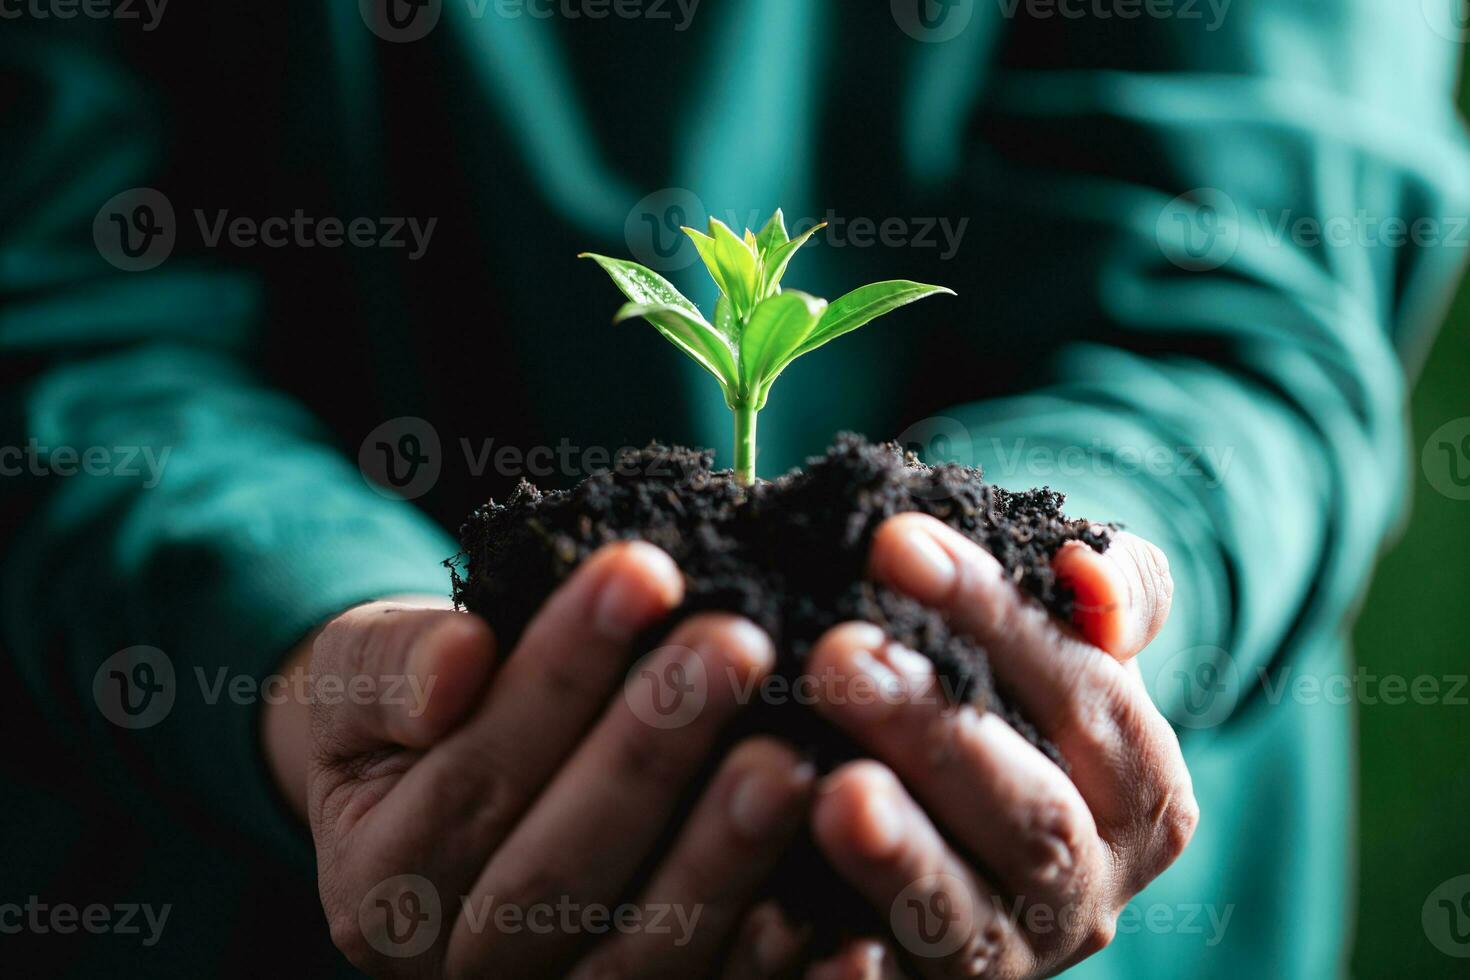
[872, 514, 1200, 890]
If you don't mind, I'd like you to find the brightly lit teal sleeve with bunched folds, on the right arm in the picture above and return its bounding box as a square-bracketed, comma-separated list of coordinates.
[958, 0, 1470, 719]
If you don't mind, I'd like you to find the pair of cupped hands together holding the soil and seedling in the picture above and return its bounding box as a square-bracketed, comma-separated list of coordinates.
[265, 514, 1198, 979]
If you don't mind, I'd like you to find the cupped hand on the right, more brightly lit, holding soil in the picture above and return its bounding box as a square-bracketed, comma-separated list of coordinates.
[809, 514, 1198, 977]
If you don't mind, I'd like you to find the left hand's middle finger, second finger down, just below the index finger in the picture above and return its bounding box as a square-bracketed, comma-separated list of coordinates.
[450, 614, 775, 976]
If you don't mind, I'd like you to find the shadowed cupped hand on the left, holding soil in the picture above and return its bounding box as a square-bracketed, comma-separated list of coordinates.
[288, 544, 813, 977]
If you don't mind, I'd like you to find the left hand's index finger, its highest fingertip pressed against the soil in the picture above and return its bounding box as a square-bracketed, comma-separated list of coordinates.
[365, 542, 684, 875]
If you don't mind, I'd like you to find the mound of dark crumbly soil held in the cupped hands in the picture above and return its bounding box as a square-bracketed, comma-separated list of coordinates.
[447, 433, 1108, 933]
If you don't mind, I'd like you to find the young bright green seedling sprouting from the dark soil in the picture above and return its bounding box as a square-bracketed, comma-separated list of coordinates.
[579, 209, 954, 485]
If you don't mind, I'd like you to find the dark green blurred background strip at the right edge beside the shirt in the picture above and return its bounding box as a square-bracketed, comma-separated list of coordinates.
[1352, 70, 1470, 977]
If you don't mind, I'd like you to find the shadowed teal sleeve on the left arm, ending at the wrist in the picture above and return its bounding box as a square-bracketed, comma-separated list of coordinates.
[0, 30, 454, 857]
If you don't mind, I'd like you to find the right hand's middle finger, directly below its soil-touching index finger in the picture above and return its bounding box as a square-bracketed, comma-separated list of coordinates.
[807, 623, 1108, 949]
